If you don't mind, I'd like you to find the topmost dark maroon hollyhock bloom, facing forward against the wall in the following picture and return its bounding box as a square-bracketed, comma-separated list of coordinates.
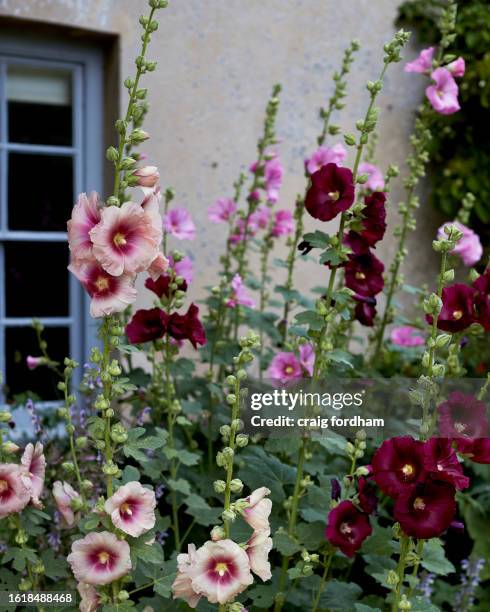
[305, 164, 355, 221]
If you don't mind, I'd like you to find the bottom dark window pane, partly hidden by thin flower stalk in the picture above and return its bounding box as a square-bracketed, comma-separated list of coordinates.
[5, 327, 69, 400]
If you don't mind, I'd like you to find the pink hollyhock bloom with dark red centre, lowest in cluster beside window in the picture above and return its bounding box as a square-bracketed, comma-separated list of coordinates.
[68, 260, 137, 317]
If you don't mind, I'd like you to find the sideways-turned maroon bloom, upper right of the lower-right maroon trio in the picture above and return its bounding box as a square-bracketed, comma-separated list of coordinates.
[424, 438, 470, 490]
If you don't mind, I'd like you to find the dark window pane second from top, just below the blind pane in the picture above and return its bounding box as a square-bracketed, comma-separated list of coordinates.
[8, 153, 73, 232]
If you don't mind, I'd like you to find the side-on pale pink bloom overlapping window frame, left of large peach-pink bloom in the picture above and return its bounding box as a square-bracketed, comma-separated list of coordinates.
[67, 191, 100, 260]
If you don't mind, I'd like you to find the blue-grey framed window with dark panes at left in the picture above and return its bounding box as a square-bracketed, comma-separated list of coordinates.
[0, 36, 103, 401]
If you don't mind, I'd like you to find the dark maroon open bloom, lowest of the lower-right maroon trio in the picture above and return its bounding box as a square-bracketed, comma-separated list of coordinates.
[393, 482, 456, 540]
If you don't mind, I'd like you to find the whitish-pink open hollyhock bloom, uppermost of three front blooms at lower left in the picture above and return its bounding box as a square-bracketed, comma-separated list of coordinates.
[104, 481, 157, 538]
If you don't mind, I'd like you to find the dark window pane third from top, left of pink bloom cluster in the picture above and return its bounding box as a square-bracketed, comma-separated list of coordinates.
[4, 242, 69, 317]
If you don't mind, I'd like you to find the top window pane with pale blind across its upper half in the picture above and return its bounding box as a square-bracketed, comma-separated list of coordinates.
[7, 65, 72, 146]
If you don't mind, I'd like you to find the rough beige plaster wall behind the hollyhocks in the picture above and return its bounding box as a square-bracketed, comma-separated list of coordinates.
[0, 0, 436, 316]
